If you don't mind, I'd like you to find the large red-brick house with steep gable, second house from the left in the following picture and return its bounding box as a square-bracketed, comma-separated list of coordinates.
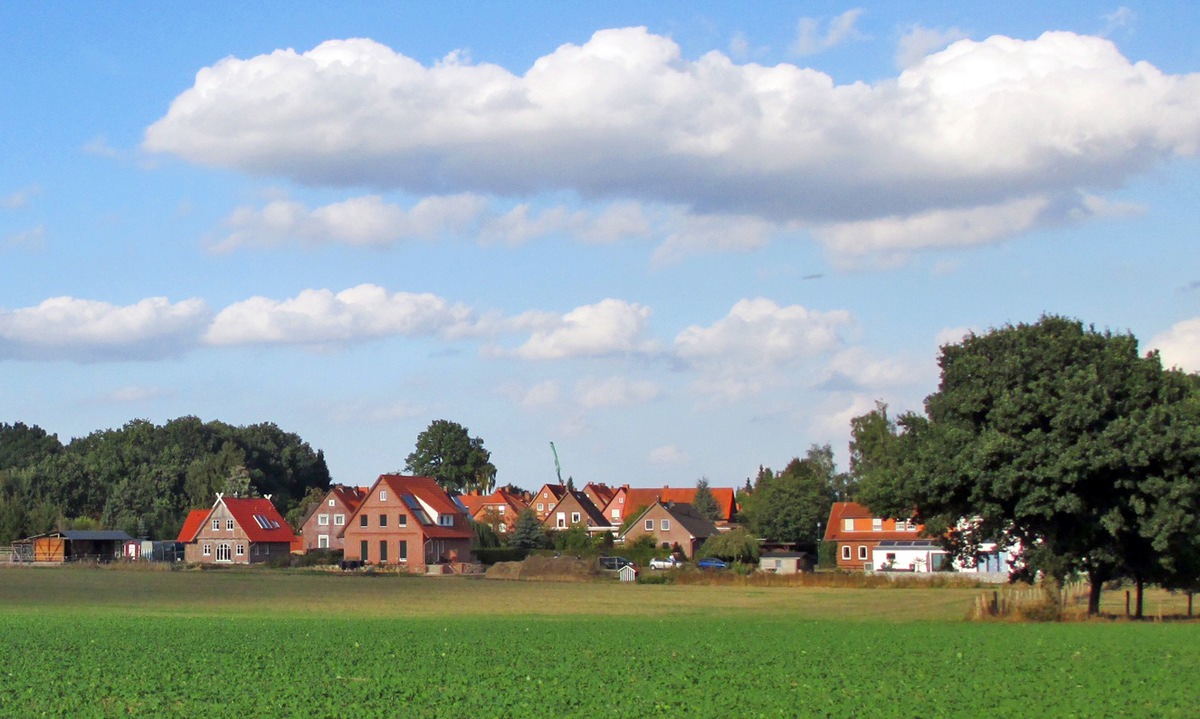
[342, 474, 475, 574]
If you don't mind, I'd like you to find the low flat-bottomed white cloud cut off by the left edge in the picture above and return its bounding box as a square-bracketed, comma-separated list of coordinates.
[0, 296, 210, 361]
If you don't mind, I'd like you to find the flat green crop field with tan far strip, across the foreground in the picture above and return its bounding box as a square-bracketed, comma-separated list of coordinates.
[0, 569, 1200, 718]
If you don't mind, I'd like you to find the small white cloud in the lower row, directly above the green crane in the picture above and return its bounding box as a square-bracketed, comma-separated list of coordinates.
[514, 299, 656, 359]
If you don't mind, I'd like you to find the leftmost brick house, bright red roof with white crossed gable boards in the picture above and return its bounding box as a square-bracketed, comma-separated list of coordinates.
[178, 493, 296, 564]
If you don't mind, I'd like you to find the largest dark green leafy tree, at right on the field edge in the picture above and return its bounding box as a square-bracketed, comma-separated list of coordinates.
[863, 317, 1200, 613]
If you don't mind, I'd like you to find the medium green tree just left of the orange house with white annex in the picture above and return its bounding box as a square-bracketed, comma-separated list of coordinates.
[743, 444, 841, 545]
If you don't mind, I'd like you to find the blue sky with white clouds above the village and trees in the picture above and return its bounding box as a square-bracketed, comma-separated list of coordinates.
[0, 0, 1200, 489]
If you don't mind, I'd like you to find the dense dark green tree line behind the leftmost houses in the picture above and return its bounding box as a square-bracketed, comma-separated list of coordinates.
[0, 417, 330, 544]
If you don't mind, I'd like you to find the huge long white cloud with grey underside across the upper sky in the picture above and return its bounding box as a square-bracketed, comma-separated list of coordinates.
[144, 30, 1200, 264]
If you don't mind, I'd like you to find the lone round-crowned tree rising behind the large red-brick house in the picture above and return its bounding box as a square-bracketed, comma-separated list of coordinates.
[404, 419, 496, 495]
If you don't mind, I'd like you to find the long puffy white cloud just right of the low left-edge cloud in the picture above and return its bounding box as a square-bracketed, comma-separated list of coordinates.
[204, 284, 470, 346]
